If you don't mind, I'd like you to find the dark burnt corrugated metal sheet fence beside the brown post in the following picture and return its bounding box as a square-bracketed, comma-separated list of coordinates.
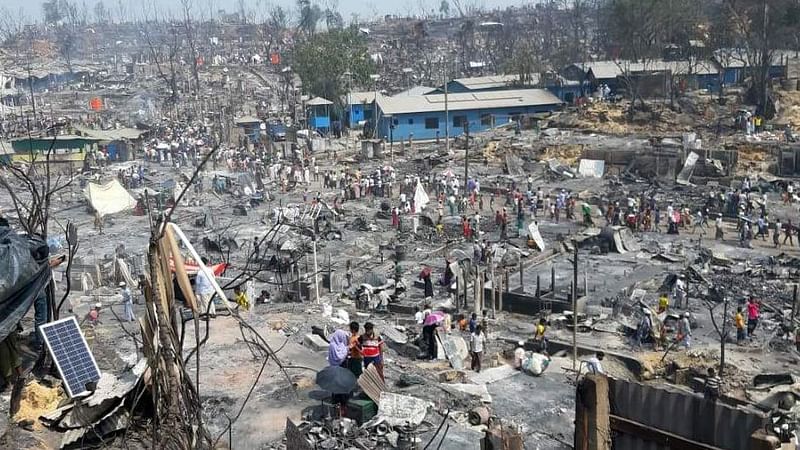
[608, 379, 767, 450]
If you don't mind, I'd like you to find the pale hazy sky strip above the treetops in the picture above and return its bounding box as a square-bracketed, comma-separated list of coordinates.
[0, 0, 530, 21]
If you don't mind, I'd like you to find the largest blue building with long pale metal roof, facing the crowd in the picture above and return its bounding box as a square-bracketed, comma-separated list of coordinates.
[377, 89, 562, 141]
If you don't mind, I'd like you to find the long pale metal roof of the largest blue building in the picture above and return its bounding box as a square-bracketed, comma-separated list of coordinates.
[378, 89, 561, 114]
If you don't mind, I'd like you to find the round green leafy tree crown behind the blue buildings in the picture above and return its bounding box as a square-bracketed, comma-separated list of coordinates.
[290, 27, 375, 104]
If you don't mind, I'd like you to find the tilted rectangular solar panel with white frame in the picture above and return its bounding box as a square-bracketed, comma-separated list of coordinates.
[39, 317, 100, 397]
